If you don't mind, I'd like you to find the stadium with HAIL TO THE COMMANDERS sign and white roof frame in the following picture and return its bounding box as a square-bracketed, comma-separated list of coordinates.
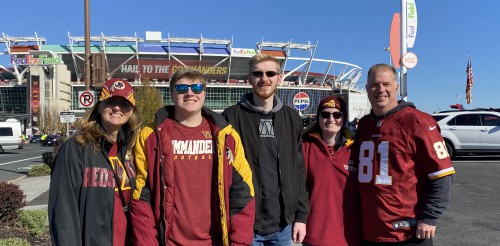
[0, 32, 364, 117]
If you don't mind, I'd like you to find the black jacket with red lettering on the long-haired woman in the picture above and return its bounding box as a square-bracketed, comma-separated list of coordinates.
[48, 131, 136, 246]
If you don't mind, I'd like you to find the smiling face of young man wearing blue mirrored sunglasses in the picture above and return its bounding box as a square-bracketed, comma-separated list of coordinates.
[171, 78, 206, 115]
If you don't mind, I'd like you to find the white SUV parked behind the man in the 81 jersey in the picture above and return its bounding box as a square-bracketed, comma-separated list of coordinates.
[432, 109, 500, 157]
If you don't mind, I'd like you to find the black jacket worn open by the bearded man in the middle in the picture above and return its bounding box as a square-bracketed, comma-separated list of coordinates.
[222, 93, 309, 231]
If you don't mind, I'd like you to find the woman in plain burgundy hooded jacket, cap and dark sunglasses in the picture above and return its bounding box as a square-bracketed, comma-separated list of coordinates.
[302, 96, 361, 246]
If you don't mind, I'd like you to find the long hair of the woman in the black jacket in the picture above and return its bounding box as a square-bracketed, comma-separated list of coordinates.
[76, 102, 141, 151]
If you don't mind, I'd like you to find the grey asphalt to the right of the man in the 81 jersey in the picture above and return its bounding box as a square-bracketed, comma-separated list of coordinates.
[434, 156, 500, 246]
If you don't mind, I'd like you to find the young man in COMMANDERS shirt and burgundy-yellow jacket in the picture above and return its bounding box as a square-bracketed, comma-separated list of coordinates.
[131, 68, 255, 246]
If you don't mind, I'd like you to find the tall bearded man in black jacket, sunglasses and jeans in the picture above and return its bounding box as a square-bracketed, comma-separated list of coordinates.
[223, 54, 309, 245]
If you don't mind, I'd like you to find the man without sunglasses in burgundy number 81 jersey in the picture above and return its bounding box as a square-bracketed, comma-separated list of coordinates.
[356, 64, 455, 245]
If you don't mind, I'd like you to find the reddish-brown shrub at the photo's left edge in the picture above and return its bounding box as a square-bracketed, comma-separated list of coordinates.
[0, 182, 26, 226]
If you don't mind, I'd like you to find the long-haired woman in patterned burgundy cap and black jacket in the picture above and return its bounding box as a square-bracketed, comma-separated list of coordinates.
[48, 79, 141, 246]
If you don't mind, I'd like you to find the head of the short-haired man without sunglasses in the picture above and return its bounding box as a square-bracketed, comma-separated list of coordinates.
[366, 69, 398, 116]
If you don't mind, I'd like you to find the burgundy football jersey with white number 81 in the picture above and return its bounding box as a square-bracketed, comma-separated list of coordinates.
[356, 107, 455, 242]
